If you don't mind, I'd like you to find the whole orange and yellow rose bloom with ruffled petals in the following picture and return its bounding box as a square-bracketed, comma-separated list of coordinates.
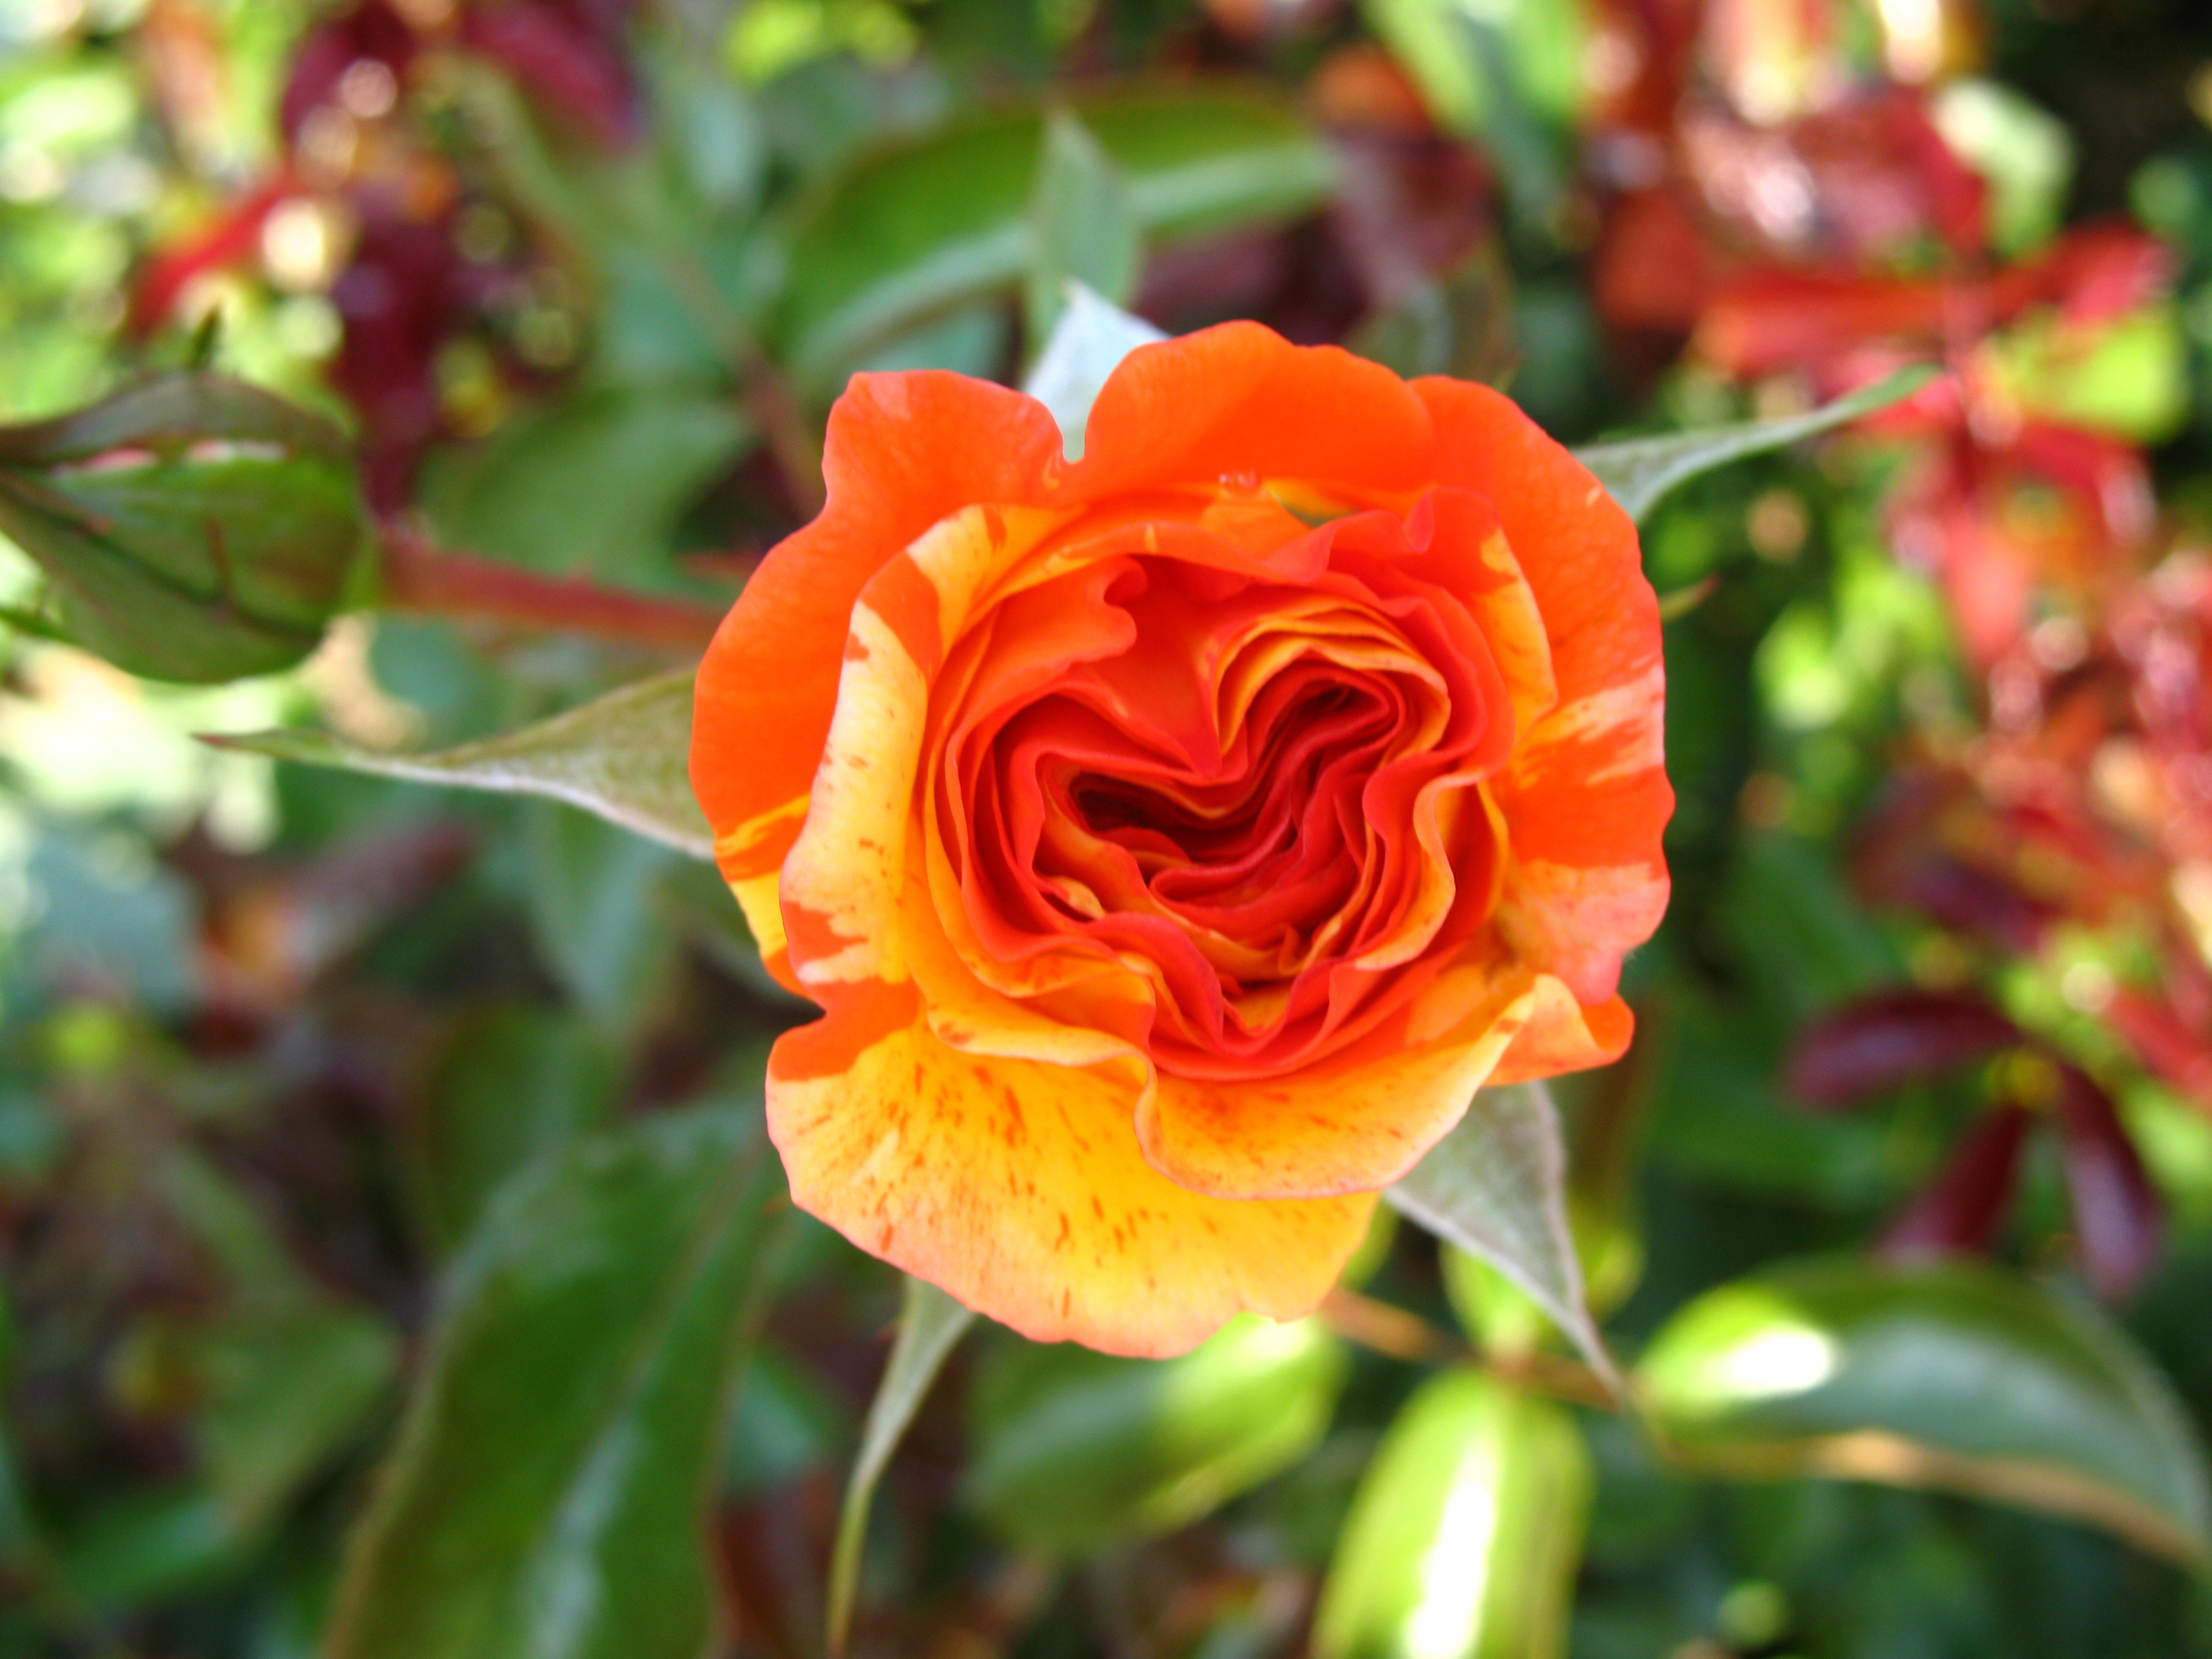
[692, 323, 1672, 1354]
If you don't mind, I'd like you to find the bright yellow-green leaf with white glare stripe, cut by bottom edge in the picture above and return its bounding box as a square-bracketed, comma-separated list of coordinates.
[1314, 1372, 1595, 1659]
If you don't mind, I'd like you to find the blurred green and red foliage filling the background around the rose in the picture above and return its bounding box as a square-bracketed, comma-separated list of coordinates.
[0, 0, 2212, 1659]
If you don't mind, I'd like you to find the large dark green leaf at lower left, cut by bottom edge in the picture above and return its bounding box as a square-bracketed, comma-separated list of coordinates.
[325, 1106, 781, 1659]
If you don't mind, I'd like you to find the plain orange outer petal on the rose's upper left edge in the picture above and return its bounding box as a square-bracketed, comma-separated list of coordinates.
[690, 374, 1062, 977]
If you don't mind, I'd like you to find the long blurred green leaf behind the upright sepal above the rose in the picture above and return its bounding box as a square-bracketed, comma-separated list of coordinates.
[776, 89, 1334, 396]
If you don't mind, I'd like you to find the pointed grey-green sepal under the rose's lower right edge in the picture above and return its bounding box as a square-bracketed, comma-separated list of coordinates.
[1382, 1084, 1619, 1392]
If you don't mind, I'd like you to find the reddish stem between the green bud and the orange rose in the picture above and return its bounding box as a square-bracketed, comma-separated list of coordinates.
[378, 522, 721, 655]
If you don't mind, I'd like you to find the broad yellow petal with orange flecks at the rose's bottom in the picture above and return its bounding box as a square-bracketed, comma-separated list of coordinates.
[768, 987, 1373, 1356]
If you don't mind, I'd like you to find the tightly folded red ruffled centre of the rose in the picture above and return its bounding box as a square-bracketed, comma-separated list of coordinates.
[931, 493, 1513, 1078]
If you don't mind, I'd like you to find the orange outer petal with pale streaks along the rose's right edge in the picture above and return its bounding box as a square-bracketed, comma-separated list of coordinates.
[1413, 380, 1675, 1007]
